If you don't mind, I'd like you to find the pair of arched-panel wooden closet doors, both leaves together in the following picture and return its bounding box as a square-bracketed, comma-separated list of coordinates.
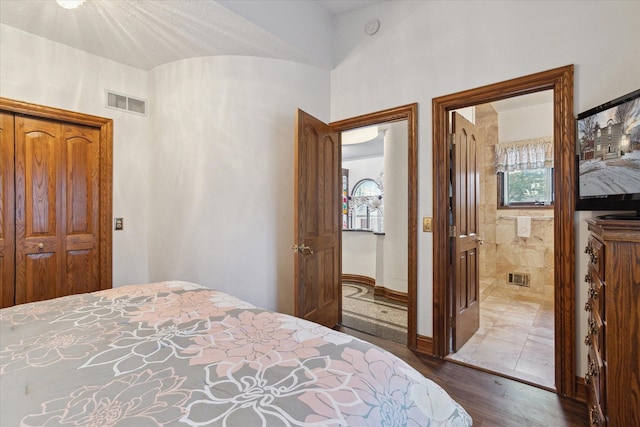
[15, 116, 100, 304]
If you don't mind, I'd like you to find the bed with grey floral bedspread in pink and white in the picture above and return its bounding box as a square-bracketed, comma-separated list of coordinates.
[0, 281, 471, 427]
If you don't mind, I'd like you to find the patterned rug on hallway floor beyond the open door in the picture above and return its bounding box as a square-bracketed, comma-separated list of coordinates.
[342, 283, 407, 345]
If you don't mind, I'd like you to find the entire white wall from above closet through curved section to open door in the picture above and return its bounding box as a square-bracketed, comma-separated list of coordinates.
[0, 25, 330, 313]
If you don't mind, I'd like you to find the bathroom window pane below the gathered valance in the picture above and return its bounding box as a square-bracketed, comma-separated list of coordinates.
[498, 168, 554, 207]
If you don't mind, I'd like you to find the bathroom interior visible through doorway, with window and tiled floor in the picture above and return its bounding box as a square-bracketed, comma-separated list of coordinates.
[447, 94, 555, 390]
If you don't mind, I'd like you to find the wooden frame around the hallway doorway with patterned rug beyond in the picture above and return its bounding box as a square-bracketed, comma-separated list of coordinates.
[329, 103, 418, 350]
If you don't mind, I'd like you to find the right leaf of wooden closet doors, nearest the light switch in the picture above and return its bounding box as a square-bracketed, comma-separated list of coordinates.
[64, 126, 100, 293]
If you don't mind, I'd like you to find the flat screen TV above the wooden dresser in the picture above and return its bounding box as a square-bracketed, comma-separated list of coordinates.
[576, 89, 640, 217]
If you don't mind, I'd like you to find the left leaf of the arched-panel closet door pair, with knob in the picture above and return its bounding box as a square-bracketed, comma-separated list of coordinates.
[15, 116, 64, 304]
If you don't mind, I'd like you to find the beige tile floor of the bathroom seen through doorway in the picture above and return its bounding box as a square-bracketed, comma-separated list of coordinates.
[448, 285, 555, 389]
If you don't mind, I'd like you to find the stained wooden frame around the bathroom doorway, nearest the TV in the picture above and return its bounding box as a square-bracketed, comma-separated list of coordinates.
[432, 65, 576, 398]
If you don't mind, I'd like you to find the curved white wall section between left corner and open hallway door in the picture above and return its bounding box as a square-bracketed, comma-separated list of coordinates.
[149, 56, 329, 313]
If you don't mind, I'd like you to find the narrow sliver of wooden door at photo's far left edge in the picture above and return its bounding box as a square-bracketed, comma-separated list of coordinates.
[0, 111, 15, 308]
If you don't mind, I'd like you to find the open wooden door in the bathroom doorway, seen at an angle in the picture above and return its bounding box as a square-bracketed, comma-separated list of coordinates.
[451, 112, 480, 351]
